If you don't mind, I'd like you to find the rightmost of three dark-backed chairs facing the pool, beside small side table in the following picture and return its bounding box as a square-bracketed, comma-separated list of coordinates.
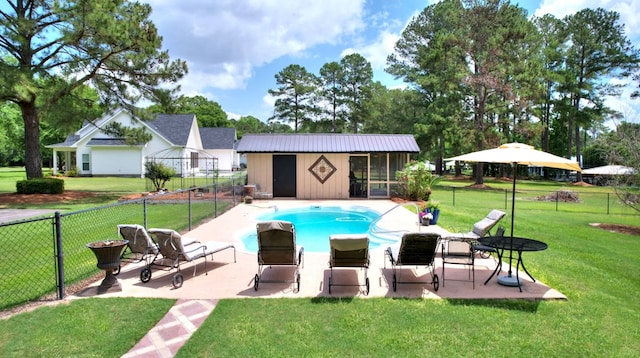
[384, 232, 440, 292]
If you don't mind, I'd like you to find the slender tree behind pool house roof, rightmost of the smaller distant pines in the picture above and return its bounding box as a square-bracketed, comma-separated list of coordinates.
[340, 53, 373, 133]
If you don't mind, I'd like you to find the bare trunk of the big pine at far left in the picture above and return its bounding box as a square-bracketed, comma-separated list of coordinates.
[19, 102, 42, 179]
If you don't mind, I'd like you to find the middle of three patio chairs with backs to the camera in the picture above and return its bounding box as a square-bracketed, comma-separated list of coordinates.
[329, 234, 370, 295]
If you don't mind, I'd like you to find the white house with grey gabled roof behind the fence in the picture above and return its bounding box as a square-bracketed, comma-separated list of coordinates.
[47, 109, 238, 177]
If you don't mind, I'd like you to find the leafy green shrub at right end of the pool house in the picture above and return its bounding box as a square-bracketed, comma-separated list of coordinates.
[396, 161, 440, 200]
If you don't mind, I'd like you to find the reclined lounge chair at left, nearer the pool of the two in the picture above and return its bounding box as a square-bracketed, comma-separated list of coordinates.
[140, 229, 236, 288]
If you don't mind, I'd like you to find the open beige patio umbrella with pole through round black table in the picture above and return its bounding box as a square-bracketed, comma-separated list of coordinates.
[446, 143, 581, 286]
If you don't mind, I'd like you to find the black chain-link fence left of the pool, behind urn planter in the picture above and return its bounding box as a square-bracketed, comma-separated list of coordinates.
[0, 178, 244, 310]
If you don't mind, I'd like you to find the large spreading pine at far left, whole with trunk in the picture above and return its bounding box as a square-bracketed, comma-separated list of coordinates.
[0, 0, 187, 178]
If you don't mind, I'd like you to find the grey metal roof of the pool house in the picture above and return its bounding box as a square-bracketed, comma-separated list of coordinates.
[238, 133, 420, 153]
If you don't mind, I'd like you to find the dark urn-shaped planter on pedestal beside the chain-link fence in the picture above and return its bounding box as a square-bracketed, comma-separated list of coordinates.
[87, 240, 129, 294]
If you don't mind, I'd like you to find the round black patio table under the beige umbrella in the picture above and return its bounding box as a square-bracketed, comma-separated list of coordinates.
[478, 236, 548, 292]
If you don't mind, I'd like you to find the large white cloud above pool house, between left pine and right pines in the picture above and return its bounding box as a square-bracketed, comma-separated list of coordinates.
[149, 0, 364, 89]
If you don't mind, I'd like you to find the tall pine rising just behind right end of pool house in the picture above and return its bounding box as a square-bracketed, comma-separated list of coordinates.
[386, 0, 471, 173]
